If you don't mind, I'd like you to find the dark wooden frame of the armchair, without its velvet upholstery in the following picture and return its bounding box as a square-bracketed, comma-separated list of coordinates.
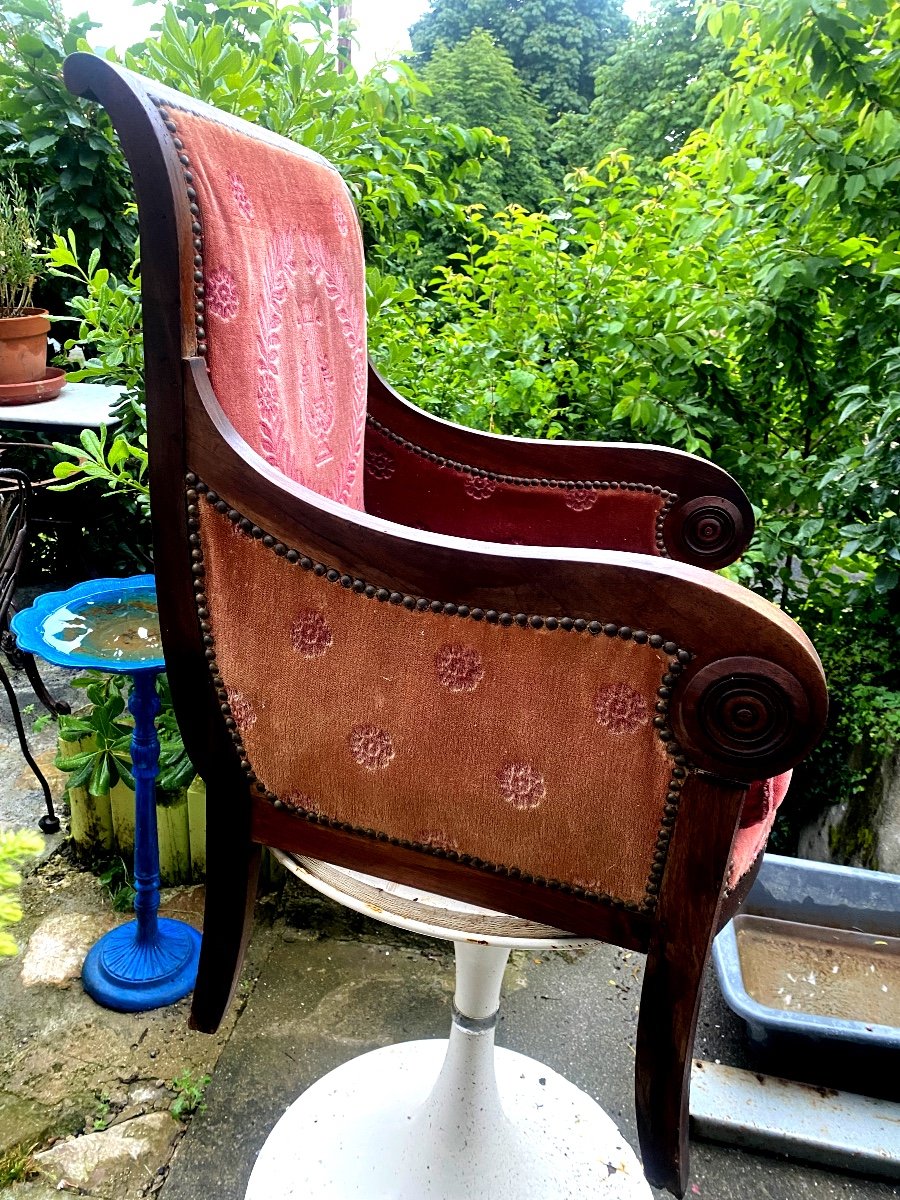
[65, 54, 827, 1196]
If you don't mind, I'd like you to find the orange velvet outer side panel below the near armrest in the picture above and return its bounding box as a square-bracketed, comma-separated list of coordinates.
[200, 505, 684, 911]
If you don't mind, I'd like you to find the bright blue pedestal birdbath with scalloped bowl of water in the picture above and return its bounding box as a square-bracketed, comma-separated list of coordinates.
[12, 575, 200, 1013]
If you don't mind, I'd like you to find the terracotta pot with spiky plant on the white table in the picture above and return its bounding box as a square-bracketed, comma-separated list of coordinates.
[0, 174, 65, 404]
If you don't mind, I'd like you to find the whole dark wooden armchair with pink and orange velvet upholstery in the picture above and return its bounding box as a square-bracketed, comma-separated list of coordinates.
[66, 54, 827, 1195]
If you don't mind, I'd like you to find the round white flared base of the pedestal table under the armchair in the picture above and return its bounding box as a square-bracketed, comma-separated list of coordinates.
[246, 1024, 652, 1200]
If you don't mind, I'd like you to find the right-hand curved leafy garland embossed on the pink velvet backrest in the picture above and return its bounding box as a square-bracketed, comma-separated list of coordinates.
[300, 232, 368, 504]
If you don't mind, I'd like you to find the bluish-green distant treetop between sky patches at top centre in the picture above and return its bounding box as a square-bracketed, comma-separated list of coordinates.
[409, 0, 628, 116]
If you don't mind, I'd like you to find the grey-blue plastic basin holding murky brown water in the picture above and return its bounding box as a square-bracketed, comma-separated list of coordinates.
[713, 854, 900, 1094]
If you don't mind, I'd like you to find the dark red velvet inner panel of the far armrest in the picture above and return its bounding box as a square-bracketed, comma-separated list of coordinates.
[365, 420, 677, 554]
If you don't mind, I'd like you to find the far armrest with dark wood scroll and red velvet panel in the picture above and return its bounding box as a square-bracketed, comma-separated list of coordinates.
[365, 364, 754, 570]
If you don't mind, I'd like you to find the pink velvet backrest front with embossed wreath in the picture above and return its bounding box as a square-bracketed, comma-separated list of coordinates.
[163, 107, 366, 509]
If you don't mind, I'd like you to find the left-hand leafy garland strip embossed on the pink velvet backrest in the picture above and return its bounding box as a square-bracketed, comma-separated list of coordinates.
[257, 232, 296, 474]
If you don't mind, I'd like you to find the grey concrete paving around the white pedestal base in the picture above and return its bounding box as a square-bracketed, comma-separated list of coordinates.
[160, 880, 896, 1200]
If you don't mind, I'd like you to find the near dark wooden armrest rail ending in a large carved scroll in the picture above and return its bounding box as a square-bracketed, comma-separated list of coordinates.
[181, 359, 828, 782]
